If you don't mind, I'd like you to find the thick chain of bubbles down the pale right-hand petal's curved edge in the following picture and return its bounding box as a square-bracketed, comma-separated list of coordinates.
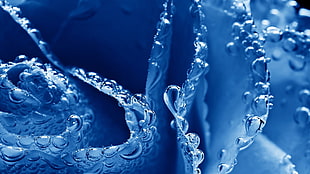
[218, 1, 273, 174]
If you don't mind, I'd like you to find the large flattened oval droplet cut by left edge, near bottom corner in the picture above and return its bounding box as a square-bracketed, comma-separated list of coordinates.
[1, 146, 25, 162]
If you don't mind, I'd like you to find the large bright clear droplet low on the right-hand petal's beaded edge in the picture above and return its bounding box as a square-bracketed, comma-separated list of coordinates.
[245, 116, 265, 137]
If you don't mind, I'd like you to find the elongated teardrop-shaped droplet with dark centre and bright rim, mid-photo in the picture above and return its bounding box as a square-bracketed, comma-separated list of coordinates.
[164, 85, 180, 116]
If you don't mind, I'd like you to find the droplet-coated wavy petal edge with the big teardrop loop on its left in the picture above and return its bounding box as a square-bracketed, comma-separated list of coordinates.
[164, 0, 208, 174]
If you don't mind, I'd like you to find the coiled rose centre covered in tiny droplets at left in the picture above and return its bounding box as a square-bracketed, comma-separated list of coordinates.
[0, 58, 93, 173]
